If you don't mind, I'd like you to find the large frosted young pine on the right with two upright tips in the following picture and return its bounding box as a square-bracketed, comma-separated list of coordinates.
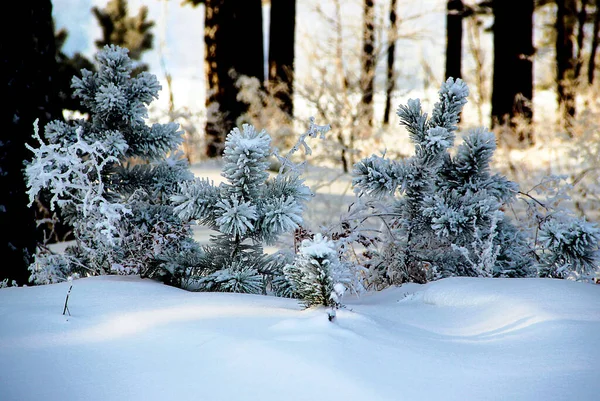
[353, 78, 531, 283]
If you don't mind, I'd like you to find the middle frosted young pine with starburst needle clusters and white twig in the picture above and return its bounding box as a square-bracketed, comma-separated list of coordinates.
[171, 120, 329, 295]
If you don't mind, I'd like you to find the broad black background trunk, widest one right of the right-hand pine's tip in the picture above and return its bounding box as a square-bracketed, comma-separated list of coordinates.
[491, 0, 534, 144]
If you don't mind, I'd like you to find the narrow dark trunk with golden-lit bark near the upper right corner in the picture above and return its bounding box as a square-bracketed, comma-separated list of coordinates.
[556, 0, 577, 132]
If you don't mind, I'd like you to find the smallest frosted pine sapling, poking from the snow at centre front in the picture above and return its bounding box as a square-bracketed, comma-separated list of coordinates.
[283, 233, 351, 308]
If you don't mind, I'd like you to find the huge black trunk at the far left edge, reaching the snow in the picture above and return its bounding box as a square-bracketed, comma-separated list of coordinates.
[0, 0, 60, 285]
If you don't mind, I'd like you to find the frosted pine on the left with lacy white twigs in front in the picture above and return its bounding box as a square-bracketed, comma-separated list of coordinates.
[26, 45, 194, 284]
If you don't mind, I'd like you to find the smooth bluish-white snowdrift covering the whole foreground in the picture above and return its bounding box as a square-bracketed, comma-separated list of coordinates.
[0, 276, 600, 401]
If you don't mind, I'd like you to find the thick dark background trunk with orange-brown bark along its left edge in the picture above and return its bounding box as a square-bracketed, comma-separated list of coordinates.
[204, 0, 265, 157]
